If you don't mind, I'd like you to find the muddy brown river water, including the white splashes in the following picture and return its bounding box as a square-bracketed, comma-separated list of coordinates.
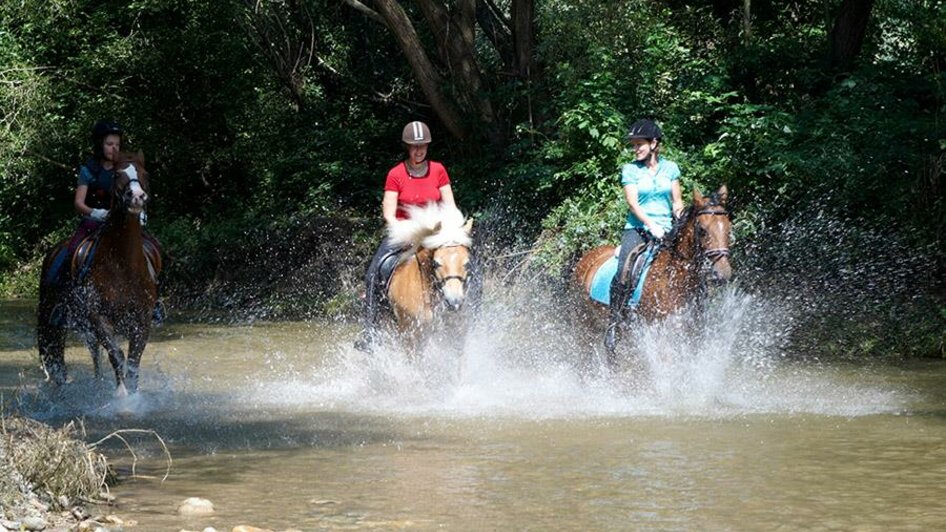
[0, 294, 946, 530]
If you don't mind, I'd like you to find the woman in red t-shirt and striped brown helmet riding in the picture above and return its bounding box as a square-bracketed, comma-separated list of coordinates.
[355, 121, 456, 352]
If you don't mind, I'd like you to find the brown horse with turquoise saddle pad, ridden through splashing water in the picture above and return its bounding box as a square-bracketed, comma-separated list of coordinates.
[574, 185, 732, 367]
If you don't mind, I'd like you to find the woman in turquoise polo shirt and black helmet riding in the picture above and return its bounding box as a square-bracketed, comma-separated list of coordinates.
[604, 119, 683, 351]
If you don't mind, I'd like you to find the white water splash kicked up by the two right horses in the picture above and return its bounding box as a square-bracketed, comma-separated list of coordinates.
[257, 286, 907, 419]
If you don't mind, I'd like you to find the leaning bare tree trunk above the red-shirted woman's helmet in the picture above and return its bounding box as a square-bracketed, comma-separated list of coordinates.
[375, 0, 466, 139]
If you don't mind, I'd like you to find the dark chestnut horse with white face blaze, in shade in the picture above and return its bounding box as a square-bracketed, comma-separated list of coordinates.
[37, 152, 161, 396]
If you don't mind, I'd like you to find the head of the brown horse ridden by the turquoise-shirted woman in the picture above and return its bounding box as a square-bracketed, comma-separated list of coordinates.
[691, 185, 732, 283]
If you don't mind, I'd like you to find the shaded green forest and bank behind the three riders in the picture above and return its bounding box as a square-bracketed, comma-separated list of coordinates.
[0, 0, 946, 355]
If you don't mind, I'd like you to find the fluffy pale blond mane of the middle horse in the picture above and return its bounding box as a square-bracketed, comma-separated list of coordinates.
[387, 203, 473, 256]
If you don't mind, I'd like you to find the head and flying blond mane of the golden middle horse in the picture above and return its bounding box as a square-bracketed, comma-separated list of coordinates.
[389, 204, 473, 310]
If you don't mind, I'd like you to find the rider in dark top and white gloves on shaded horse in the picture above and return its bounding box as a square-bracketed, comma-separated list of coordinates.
[49, 120, 165, 324]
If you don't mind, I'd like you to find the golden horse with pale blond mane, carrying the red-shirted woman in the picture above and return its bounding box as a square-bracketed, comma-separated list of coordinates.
[387, 203, 473, 349]
